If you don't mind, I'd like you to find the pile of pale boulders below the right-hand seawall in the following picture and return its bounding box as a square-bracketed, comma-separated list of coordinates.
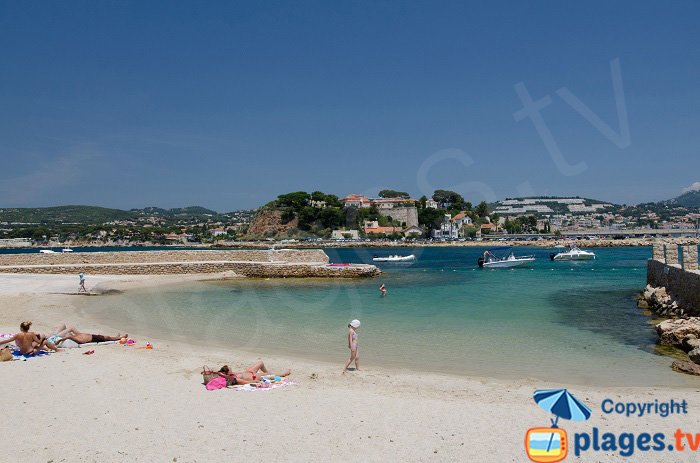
[637, 285, 700, 376]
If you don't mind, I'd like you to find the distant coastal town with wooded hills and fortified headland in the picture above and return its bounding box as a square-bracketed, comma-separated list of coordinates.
[0, 190, 700, 247]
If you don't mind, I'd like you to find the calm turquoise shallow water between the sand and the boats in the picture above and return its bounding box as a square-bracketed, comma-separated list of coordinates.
[79, 247, 700, 386]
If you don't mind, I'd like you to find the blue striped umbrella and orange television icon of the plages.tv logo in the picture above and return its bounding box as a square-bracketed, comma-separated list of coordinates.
[525, 389, 591, 463]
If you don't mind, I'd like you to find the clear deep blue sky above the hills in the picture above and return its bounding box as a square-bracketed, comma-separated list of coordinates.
[0, 0, 700, 212]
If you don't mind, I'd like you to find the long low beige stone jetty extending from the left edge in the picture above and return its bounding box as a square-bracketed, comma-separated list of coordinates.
[0, 249, 381, 278]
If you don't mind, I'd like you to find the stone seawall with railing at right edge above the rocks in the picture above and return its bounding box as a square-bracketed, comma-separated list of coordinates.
[647, 243, 700, 315]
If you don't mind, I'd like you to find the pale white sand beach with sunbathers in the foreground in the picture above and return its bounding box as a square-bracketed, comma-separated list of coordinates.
[0, 275, 700, 463]
